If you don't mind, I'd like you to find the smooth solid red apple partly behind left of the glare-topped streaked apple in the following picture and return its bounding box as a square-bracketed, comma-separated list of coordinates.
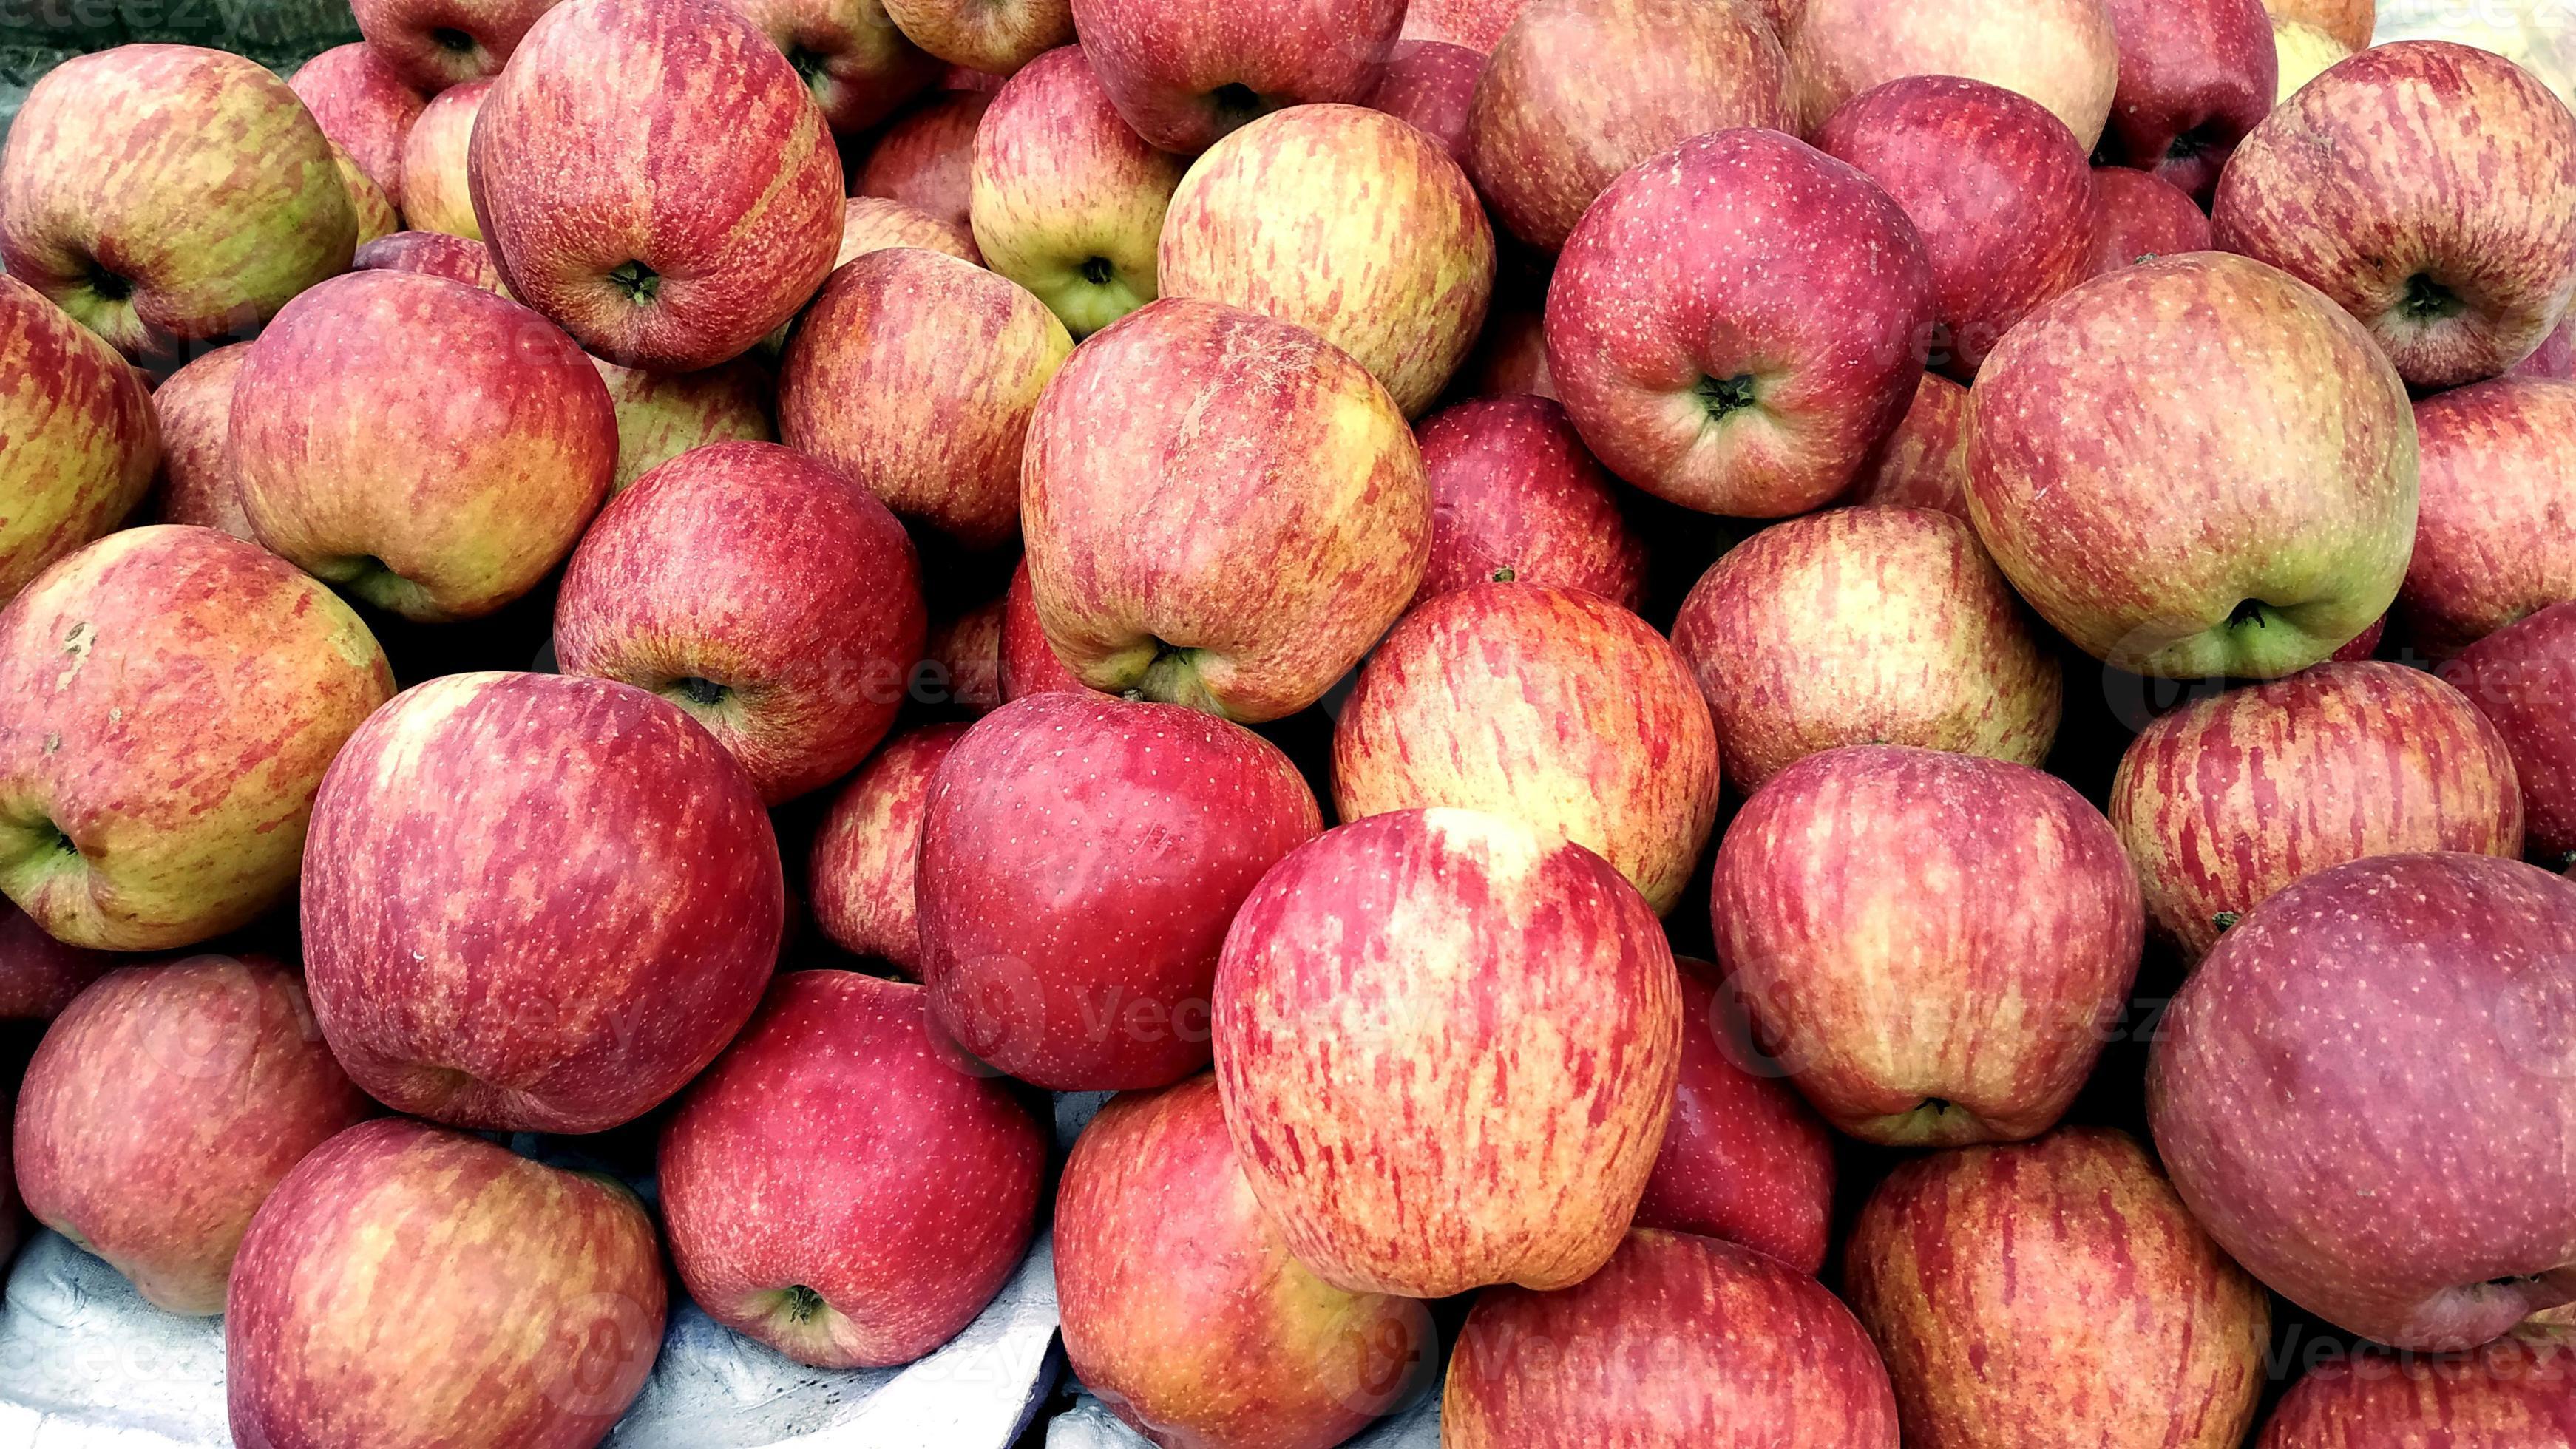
[917, 692, 1324, 1091]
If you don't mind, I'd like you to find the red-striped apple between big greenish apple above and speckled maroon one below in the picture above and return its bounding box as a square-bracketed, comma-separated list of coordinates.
[2109, 664, 2522, 957]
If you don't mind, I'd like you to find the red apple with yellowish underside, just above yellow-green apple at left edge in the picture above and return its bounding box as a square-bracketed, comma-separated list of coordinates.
[232, 271, 618, 622]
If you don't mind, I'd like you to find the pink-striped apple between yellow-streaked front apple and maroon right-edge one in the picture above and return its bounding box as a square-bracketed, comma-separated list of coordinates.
[1708, 744, 2146, 1148]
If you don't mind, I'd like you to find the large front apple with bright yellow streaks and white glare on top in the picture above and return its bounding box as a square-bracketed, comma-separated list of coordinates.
[1216, 808, 1682, 1297]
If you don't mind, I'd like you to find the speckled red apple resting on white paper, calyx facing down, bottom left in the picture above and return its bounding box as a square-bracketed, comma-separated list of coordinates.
[657, 970, 1046, 1369]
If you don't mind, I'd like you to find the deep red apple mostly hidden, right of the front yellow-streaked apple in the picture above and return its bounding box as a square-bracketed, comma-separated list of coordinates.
[1636, 957, 1834, 1274]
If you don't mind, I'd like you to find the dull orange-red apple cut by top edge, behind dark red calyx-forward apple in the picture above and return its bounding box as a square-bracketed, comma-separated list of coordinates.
[1465, 0, 1792, 252]
